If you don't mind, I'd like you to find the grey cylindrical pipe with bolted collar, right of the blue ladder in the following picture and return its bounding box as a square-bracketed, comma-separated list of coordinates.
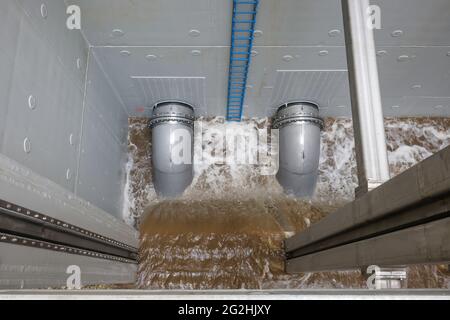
[273, 102, 324, 198]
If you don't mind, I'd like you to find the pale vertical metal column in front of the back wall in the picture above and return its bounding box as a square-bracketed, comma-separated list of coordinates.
[342, 0, 390, 197]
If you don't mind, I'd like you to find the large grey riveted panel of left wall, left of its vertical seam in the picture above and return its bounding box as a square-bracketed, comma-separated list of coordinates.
[1, 0, 87, 191]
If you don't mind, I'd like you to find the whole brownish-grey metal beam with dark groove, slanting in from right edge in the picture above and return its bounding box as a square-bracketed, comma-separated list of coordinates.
[285, 147, 450, 272]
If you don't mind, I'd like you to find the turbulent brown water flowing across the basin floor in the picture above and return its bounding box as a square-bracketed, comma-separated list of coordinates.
[124, 118, 450, 289]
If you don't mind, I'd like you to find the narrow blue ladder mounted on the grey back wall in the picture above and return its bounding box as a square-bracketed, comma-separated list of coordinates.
[227, 0, 259, 122]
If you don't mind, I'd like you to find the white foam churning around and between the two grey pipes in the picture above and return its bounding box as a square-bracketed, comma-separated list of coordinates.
[123, 118, 450, 224]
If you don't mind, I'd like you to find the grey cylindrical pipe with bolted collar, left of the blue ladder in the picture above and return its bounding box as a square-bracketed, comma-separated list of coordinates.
[150, 102, 195, 198]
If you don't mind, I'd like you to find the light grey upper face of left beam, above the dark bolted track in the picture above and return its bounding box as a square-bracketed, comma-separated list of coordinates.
[0, 154, 138, 247]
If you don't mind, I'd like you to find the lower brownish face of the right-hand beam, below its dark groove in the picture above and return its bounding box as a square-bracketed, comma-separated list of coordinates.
[286, 218, 450, 273]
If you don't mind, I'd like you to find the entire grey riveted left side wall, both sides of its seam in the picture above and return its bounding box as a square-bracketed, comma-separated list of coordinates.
[0, 0, 128, 217]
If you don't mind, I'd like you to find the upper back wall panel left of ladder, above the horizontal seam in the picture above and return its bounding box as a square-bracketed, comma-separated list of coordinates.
[71, 0, 232, 46]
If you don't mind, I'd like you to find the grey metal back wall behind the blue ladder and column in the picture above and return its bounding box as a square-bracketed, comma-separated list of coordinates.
[70, 0, 450, 117]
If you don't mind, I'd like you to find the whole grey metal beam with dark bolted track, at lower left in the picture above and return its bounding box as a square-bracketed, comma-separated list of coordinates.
[0, 154, 138, 289]
